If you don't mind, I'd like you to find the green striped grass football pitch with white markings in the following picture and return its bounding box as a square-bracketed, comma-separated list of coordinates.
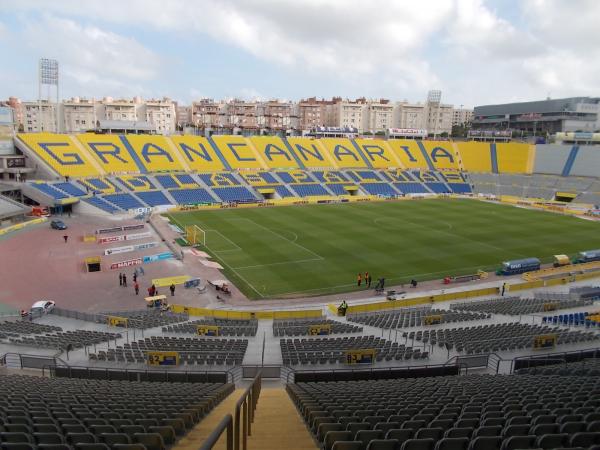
[169, 200, 600, 299]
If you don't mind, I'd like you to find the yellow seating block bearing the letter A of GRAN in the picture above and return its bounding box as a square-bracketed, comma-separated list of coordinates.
[126, 134, 187, 172]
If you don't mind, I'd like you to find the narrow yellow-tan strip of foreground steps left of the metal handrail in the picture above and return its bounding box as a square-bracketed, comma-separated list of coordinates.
[172, 389, 245, 450]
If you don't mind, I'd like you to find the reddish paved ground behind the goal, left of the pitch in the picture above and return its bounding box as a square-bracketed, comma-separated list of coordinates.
[0, 216, 217, 312]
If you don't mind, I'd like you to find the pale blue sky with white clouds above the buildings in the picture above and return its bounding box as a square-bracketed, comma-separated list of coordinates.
[0, 0, 600, 108]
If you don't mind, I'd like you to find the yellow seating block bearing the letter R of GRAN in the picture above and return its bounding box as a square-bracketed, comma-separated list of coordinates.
[75, 133, 139, 174]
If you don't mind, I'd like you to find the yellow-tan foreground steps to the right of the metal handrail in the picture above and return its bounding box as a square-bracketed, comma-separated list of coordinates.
[248, 388, 318, 450]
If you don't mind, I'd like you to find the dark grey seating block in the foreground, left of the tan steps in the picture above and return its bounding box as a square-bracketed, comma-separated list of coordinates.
[0, 375, 234, 450]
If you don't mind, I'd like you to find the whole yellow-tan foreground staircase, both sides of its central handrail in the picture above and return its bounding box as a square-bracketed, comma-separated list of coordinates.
[173, 387, 318, 450]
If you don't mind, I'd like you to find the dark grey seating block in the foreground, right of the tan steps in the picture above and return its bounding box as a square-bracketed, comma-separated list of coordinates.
[287, 375, 600, 450]
